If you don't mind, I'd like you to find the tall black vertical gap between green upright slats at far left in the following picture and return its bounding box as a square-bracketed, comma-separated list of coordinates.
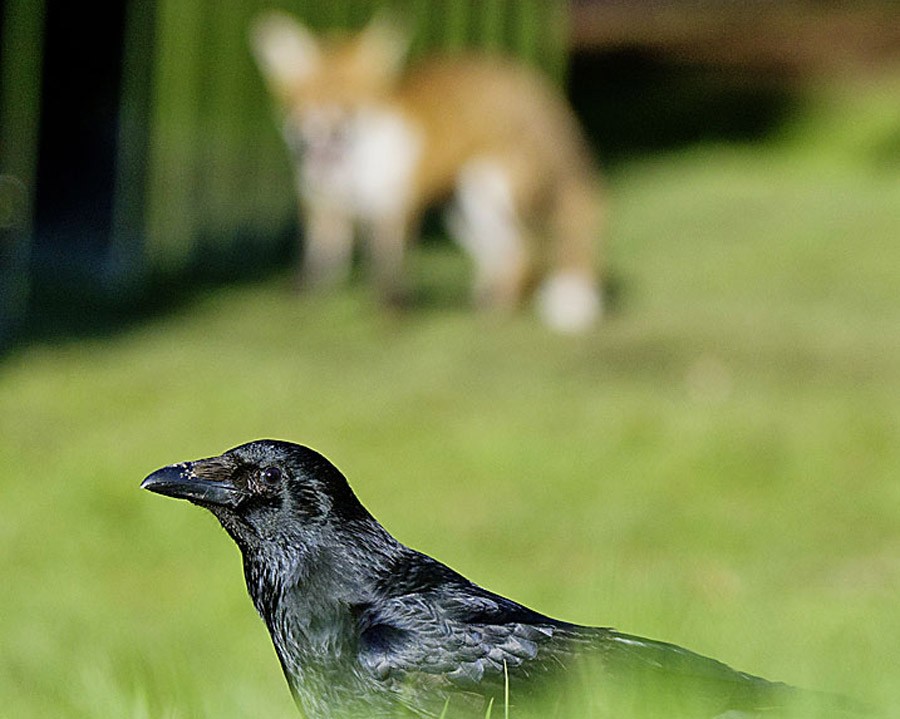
[31, 2, 126, 285]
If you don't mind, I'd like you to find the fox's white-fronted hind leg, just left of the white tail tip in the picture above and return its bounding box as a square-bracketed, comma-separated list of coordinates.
[447, 159, 530, 311]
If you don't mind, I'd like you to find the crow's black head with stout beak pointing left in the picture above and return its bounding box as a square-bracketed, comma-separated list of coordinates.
[141, 439, 370, 550]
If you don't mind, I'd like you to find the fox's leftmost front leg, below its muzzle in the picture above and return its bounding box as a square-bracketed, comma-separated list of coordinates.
[297, 203, 353, 289]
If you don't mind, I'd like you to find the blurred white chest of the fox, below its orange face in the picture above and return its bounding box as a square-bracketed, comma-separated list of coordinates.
[287, 108, 422, 220]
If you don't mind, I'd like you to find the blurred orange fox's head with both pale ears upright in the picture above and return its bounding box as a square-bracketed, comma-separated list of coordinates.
[250, 11, 409, 170]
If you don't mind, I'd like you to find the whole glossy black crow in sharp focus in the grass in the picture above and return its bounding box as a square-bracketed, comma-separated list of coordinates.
[141, 440, 852, 719]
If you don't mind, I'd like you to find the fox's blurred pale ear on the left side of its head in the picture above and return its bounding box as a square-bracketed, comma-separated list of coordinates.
[250, 10, 322, 97]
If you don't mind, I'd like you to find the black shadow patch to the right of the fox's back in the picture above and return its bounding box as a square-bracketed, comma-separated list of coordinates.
[568, 48, 802, 168]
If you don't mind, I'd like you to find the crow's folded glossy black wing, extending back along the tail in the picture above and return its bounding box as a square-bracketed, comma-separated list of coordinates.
[358, 563, 793, 716]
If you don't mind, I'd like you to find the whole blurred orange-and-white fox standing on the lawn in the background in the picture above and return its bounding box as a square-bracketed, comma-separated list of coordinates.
[251, 11, 602, 332]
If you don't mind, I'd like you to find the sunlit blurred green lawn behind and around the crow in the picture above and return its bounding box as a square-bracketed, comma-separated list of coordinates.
[0, 71, 900, 718]
